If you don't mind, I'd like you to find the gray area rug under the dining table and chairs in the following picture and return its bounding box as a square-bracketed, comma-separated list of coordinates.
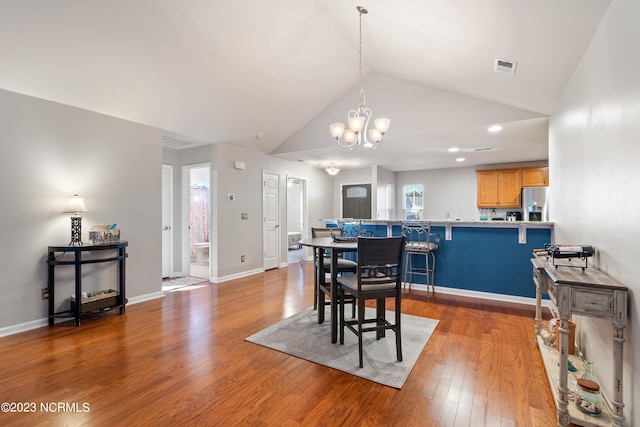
[245, 307, 438, 389]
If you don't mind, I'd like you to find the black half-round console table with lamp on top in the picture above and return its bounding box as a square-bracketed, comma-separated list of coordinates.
[47, 241, 129, 326]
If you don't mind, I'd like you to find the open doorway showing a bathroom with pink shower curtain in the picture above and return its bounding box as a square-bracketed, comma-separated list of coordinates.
[183, 164, 211, 280]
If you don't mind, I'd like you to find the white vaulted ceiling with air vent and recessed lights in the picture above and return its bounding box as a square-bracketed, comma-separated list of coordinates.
[0, 0, 611, 171]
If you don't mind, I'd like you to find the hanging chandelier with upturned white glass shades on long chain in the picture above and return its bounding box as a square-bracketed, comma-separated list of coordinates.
[329, 6, 391, 151]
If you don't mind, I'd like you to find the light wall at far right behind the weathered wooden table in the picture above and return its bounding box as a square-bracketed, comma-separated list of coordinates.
[549, 0, 640, 425]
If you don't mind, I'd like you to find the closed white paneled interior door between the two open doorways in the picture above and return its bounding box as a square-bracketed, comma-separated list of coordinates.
[262, 172, 280, 270]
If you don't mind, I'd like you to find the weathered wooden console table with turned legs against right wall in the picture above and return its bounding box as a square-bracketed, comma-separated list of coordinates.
[531, 256, 628, 427]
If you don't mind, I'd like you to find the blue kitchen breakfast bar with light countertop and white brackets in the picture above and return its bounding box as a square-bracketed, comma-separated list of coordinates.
[324, 219, 553, 304]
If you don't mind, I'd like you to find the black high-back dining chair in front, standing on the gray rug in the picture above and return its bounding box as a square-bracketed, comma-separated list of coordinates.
[338, 236, 405, 368]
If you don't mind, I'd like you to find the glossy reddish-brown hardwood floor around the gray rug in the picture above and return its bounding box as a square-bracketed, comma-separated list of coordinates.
[0, 262, 556, 427]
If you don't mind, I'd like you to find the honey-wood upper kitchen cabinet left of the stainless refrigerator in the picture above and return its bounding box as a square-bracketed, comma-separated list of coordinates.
[476, 169, 522, 208]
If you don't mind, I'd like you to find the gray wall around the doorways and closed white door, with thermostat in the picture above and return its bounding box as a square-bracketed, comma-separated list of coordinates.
[163, 143, 333, 281]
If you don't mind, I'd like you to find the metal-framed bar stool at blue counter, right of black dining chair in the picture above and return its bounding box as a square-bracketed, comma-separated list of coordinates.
[402, 222, 440, 294]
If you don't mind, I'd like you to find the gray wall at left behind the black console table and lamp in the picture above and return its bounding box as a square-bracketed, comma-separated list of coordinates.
[0, 90, 162, 335]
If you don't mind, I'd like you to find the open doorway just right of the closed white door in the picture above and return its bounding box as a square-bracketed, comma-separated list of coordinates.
[287, 177, 307, 264]
